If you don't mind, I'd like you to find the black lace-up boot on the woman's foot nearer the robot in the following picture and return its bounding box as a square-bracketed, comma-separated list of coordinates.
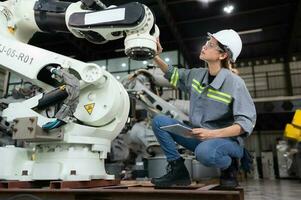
[151, 158, 191, 187]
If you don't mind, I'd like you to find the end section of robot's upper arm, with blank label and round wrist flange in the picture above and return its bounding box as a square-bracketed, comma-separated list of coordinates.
[66, 0, 159, 60]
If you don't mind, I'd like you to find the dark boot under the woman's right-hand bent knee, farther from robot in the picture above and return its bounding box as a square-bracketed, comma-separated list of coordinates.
[220, 158, 238, 189]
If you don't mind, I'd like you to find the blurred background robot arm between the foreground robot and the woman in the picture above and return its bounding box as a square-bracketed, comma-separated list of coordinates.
[122, 69, 189, 163]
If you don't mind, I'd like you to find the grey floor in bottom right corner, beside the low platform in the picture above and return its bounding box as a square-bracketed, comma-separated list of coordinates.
[240, 180, 301, 200]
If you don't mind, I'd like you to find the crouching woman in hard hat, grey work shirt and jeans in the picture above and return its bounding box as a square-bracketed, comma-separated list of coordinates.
[152, 29, 256, 188]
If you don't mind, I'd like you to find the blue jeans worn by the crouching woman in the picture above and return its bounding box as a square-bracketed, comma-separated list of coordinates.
[152, 115, 243, 170]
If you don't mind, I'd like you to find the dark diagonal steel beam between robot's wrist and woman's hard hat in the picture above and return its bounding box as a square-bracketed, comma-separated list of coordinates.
[157, 0, 192, 65]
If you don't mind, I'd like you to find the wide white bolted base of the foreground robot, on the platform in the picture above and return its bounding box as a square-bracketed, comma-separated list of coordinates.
[0, 144, 114, 181]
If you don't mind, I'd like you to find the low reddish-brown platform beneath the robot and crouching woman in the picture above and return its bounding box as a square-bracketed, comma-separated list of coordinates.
[0, 181, 244, 200]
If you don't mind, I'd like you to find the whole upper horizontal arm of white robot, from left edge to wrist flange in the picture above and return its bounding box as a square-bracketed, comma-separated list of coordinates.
[0, 0, 159, 60]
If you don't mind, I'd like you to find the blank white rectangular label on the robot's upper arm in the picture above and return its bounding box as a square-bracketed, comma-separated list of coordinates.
[85, 8, 125, 25]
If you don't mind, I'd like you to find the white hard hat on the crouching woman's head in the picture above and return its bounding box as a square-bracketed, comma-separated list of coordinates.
[208, 29, 242, 62]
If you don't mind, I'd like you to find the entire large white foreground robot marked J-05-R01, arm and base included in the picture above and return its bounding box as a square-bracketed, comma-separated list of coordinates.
[0, 0, 159, 181]
